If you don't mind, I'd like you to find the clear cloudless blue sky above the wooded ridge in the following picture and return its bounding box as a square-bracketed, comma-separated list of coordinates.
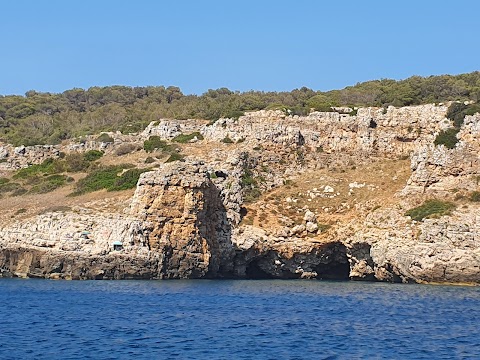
[0, 0, 480, 95]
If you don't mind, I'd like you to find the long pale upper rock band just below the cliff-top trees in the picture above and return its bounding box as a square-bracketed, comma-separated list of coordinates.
[201, 105, 450, 157]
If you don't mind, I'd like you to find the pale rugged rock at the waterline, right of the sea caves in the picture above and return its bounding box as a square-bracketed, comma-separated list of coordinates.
[345, 206, 480, 283]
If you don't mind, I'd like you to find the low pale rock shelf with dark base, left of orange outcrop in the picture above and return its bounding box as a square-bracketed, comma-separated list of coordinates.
[0, 213, 156, 279]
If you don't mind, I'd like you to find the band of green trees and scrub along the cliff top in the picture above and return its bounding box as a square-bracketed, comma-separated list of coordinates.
[0, 72, 480, 145]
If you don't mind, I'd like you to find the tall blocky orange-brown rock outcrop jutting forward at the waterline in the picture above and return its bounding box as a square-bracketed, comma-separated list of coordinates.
[132, 163, 231, 278]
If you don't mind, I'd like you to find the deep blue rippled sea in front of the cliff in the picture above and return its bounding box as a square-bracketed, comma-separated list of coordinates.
[0, 279, 480, 360]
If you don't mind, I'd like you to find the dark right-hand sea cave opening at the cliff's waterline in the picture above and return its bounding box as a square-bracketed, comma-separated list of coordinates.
[314, 244, 350, 280]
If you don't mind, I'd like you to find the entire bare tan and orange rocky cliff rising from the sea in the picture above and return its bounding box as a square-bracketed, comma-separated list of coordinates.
[0, 105, 480, 283]
